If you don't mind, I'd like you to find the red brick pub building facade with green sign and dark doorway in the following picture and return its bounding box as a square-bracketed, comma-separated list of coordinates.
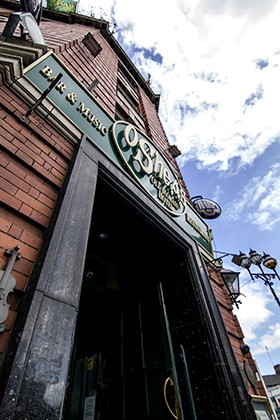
[0, 2, 274, 420]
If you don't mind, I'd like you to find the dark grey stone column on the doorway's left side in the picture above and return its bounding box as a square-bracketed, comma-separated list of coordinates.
[0, 136, 97, 420]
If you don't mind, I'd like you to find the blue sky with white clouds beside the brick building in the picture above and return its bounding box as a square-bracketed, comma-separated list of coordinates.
[78, 0, 280, 374]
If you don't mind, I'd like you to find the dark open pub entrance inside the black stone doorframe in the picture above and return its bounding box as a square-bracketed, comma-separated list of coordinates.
[65, 176, 232, 420]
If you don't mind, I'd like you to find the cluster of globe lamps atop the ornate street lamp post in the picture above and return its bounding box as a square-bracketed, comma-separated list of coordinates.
[232, 248, 280, 307]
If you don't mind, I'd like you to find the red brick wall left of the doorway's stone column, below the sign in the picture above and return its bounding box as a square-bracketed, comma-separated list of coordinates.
[0, 81, 74, 357]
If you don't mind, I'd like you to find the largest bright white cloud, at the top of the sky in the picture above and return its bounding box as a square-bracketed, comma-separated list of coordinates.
[99, 0, 280, 171]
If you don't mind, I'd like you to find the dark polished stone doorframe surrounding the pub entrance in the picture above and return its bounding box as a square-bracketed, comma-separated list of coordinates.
[1, 136, 255, 420]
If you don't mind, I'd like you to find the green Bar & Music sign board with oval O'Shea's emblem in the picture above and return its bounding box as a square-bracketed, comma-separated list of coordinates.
[24, 53, 212, 253]
